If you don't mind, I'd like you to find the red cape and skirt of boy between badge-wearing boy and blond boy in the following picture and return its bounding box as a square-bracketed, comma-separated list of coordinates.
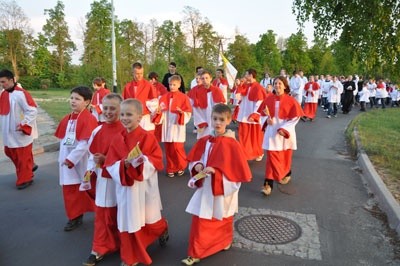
[89, 121, 125, 255]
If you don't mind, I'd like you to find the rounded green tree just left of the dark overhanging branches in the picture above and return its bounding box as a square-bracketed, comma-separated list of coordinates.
[283, 31, 312, 74]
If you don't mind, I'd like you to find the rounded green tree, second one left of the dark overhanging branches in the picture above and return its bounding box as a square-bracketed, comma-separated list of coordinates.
[255, 30, 282, 75]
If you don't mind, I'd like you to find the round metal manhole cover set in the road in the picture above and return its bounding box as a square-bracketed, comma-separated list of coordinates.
[235, 215, 301, 245]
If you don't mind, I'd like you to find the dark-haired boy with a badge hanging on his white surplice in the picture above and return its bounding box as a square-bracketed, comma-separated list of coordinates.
[54, 86, 97, 231]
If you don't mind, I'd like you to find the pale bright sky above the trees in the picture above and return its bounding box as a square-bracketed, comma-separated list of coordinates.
[16, 0, 313, 63]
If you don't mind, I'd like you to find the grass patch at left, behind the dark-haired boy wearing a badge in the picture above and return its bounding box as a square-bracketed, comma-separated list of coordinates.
[29, 89, 71, 123]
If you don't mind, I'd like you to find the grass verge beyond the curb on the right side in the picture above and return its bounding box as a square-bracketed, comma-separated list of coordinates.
[346, 107, 400, 198]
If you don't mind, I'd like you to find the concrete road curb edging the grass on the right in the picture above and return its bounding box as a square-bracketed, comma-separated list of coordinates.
[353, 128, 400, 235]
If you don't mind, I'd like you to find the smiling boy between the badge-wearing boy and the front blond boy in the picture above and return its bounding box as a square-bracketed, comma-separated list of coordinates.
[82, 93, 125, 266]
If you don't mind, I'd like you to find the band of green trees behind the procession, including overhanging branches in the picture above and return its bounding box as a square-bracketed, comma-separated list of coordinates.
[0, 0, 400, 88]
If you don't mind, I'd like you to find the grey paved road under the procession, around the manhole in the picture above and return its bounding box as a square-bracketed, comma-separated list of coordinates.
[0, 108, 400, 266]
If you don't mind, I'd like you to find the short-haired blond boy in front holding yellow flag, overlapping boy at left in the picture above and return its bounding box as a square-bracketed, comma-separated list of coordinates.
[105, 99, 169, 265]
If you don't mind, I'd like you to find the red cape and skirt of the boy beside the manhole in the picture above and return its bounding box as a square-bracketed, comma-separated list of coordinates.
[188, 136, 252, 259]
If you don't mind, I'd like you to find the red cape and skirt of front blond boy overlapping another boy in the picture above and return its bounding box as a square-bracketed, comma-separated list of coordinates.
[105, 126, 168, 265]
